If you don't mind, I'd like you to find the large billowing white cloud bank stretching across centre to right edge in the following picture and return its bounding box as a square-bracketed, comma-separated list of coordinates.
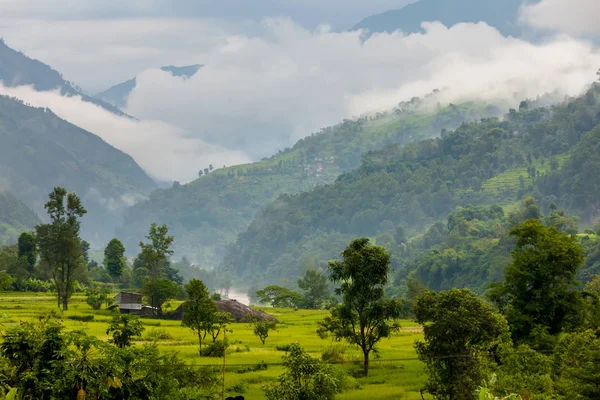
[127, 19, 600, 159]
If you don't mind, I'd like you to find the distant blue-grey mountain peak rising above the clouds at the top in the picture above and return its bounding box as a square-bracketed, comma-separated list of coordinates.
[353, 0, 523, 36]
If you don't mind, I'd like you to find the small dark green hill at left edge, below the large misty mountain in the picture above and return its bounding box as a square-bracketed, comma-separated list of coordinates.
[0, 190, 41, 246]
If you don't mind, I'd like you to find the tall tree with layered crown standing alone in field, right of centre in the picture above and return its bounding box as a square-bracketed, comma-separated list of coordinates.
[318, 238, 402, 376]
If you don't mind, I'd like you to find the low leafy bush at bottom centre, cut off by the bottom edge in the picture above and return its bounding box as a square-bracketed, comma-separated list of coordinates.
[263, 343, 341, 400]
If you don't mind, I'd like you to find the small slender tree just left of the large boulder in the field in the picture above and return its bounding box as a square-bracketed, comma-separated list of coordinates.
[181, 279, 217, 354]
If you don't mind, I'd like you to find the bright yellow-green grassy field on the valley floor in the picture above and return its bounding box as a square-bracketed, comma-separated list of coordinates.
[0, 293, 426, 400]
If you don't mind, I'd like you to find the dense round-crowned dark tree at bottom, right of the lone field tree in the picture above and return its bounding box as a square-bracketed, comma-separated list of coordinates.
[413, 289, 508, 400]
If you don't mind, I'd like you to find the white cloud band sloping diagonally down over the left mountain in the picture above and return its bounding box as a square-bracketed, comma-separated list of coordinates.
[0, 86, 249, 183]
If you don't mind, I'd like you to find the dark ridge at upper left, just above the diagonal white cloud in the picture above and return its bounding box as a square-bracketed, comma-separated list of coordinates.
[0, 39, 127, 116]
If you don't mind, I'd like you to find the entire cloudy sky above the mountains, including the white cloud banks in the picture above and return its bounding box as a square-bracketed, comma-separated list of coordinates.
[0, 0, 600, 182]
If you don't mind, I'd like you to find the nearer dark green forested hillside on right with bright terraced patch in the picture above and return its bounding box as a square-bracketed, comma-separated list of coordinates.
[223, 84, 600, 289]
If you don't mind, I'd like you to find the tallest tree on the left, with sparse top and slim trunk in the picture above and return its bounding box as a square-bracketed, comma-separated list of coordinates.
[35, 187, 86, 310]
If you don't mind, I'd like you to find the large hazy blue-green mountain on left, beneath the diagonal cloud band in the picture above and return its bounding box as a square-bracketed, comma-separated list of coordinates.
[0, 96, 155, 243]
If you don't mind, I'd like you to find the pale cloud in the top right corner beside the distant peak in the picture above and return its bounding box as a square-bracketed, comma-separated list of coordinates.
[520, 0, 600, 36]
